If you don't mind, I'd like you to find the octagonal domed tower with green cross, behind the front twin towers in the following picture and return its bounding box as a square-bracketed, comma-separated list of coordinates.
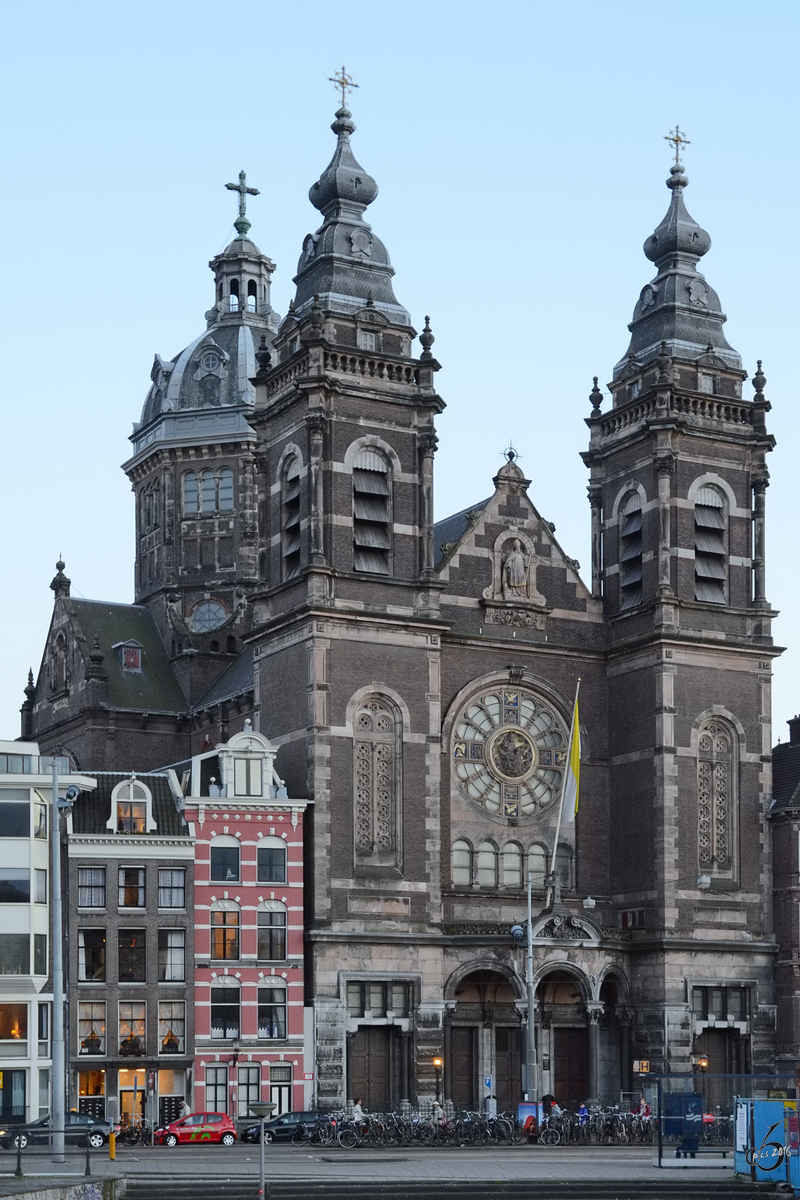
[124, 172, 277, 703]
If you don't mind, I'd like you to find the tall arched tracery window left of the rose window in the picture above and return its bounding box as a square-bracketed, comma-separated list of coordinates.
[354, 696, 402, 866]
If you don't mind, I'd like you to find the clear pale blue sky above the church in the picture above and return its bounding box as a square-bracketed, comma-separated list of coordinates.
[0, 0, 800, 737]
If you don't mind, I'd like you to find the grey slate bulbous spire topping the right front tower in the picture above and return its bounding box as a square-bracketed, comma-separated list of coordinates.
[614, 162, 741, 379]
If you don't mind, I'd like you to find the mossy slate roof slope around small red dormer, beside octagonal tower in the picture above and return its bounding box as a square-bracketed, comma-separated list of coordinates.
[66, 600, 187, 713]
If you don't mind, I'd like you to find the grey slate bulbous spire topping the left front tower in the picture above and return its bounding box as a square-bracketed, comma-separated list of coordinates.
[294, 108, 411, 325]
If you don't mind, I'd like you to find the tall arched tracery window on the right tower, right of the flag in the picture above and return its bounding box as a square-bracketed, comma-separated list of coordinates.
[697, 720, 736, 875]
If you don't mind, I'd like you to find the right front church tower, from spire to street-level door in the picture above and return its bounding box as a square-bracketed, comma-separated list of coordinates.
[584, 142, 778, 1072]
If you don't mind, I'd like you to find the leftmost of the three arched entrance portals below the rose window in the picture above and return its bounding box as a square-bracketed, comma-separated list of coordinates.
[445, 970, 522, 1109]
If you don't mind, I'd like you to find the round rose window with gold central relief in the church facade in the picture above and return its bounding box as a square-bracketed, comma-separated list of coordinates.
[452, 688, 567, 817]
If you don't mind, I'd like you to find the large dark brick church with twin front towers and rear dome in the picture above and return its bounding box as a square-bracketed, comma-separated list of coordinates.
[23, 100, 777, 1109]
